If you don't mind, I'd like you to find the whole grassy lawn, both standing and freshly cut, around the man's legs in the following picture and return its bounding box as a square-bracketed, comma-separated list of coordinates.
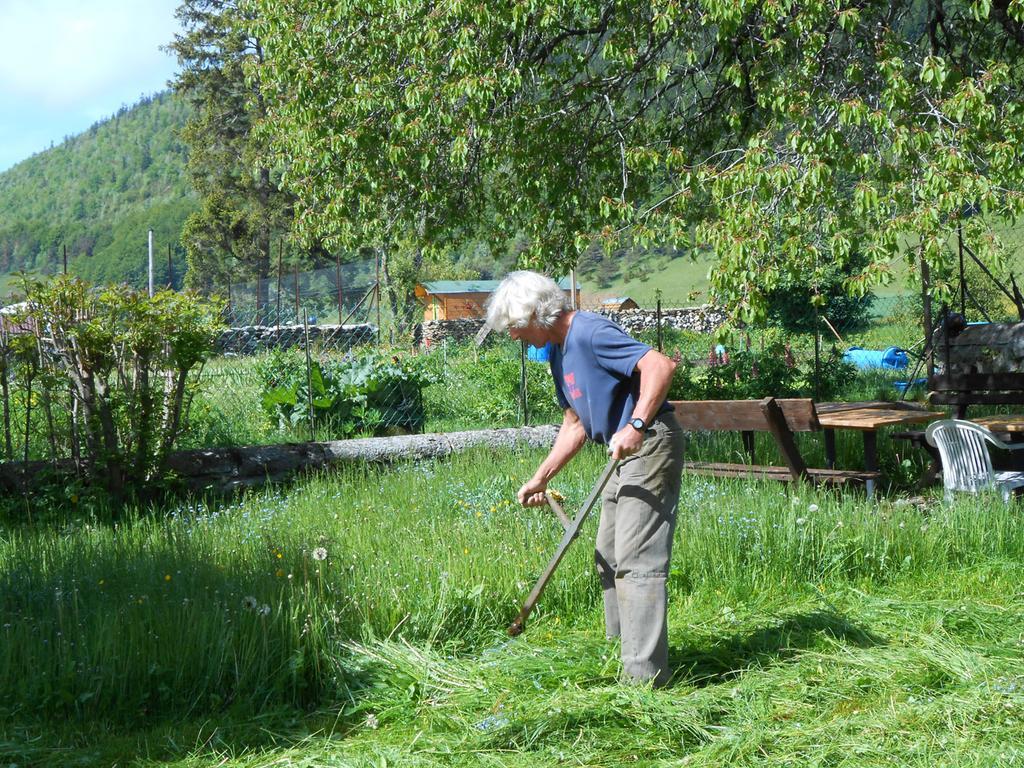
[0, 451, 1024, 767]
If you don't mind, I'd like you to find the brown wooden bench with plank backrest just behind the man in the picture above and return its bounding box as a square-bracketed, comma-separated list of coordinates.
[671, 397, 880, 485]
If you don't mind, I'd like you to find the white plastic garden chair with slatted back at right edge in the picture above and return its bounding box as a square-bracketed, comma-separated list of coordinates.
[925, 419, 1024, 503]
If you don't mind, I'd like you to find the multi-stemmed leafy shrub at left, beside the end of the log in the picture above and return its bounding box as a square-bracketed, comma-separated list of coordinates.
[5, 275, 220, 499]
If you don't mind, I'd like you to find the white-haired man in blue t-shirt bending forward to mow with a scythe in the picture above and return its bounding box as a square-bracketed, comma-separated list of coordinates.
[487, 271, 684, 685]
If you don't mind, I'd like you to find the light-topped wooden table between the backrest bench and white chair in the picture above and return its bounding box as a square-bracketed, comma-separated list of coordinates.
[815, 400, 942, 499]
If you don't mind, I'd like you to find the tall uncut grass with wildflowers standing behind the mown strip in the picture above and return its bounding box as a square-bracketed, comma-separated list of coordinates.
[0, 444, 1024, 733]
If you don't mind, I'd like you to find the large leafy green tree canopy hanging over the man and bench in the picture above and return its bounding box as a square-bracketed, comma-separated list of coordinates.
[252, 0, 1024, 319]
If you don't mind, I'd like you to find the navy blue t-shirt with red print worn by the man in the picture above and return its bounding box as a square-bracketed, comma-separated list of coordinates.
[551, 311, 672, 444]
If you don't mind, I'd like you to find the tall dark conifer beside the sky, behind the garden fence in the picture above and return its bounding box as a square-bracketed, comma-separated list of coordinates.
[169, 0, 293, 322]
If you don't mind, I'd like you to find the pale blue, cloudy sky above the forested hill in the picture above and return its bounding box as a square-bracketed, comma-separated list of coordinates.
[0, 0, 179, 172]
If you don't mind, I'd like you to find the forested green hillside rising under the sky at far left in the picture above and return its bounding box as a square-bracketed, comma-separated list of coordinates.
[0, 91, 198, 294]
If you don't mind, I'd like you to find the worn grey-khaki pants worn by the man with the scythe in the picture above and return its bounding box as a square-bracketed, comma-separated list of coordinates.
[595, 413, 685, 685]
